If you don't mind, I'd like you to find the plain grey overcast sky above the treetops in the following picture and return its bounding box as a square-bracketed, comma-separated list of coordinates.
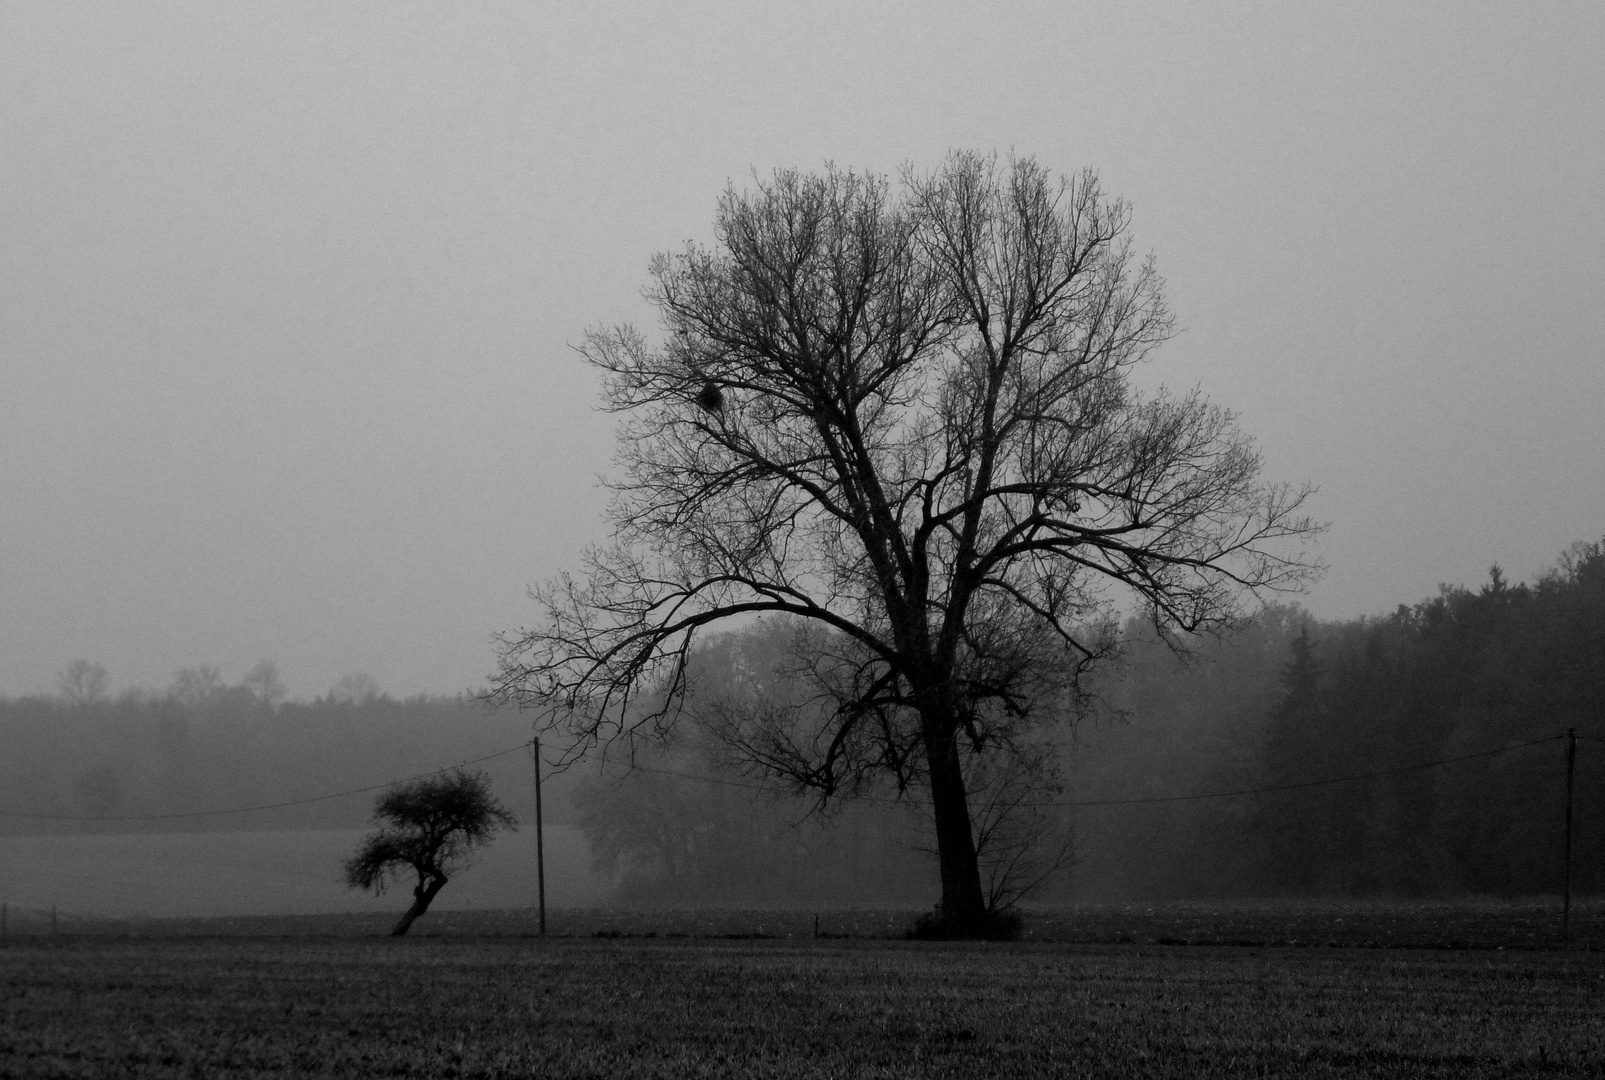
[0, 0, 1605, 696]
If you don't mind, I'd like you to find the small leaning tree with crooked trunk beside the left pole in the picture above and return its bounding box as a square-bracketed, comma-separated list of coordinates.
[345, 769, 517, 937]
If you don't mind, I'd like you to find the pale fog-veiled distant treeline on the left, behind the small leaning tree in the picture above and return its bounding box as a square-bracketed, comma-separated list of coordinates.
[0, 673, 531, 834]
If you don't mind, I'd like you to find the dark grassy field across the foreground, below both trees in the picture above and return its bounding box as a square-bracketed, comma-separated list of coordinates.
[0, 936, 1605, 1077]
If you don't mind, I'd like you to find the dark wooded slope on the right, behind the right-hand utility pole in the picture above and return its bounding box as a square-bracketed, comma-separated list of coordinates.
[1071, 544, 1605, 897]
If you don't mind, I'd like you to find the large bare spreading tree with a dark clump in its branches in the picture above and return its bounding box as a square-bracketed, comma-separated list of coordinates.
[496, 152, 1314, 936]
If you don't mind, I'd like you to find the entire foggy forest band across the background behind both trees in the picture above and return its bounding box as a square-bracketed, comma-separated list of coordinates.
[9, 542, 1605, 908]
